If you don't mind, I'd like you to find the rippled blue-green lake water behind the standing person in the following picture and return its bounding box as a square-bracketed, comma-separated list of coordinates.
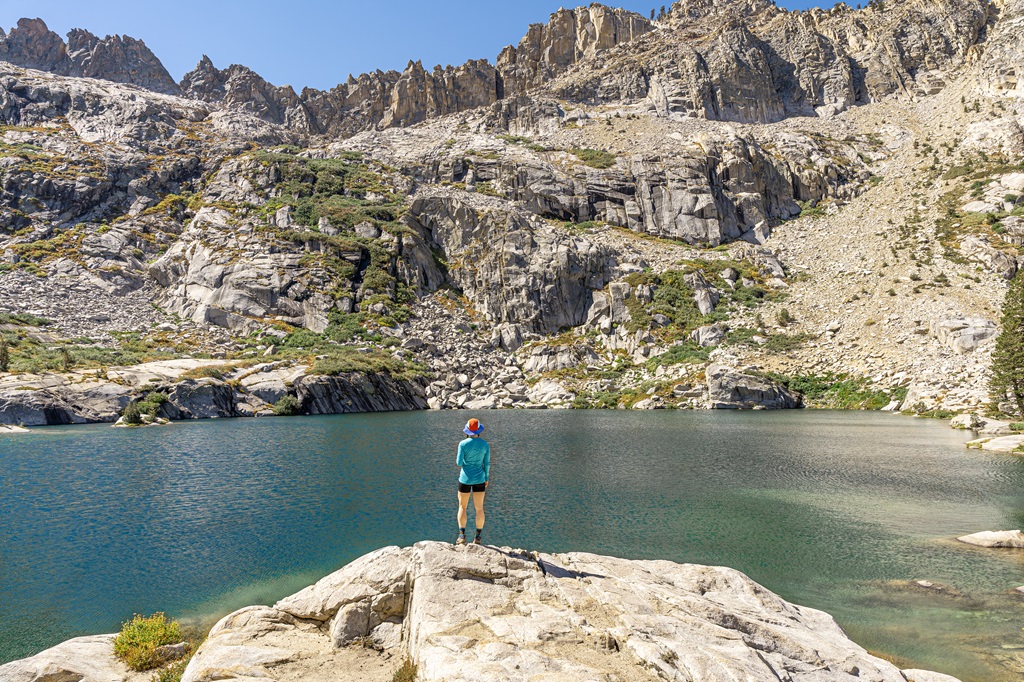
[0, 411, 1024, 681]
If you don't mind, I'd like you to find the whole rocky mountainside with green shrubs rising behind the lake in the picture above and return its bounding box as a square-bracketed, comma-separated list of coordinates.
[0, 0, 1024, 423]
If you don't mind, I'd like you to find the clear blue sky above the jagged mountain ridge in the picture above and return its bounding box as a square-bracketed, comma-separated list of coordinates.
[0, 0, 835, 90]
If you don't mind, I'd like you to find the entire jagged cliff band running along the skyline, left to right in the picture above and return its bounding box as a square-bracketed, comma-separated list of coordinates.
[0, 0, 999, 130]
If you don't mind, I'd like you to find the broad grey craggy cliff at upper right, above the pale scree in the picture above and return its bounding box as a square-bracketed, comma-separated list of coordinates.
[551, 0, 989, 123]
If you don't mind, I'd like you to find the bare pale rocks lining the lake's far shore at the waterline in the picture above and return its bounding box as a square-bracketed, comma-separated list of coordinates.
[0, 342, 803, 427]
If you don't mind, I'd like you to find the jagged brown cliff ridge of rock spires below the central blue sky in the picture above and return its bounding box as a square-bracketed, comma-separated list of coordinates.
[181, 4, 652, 136]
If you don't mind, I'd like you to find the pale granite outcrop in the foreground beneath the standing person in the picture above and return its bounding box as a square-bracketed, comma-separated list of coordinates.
[0, 542, 955, 682]
